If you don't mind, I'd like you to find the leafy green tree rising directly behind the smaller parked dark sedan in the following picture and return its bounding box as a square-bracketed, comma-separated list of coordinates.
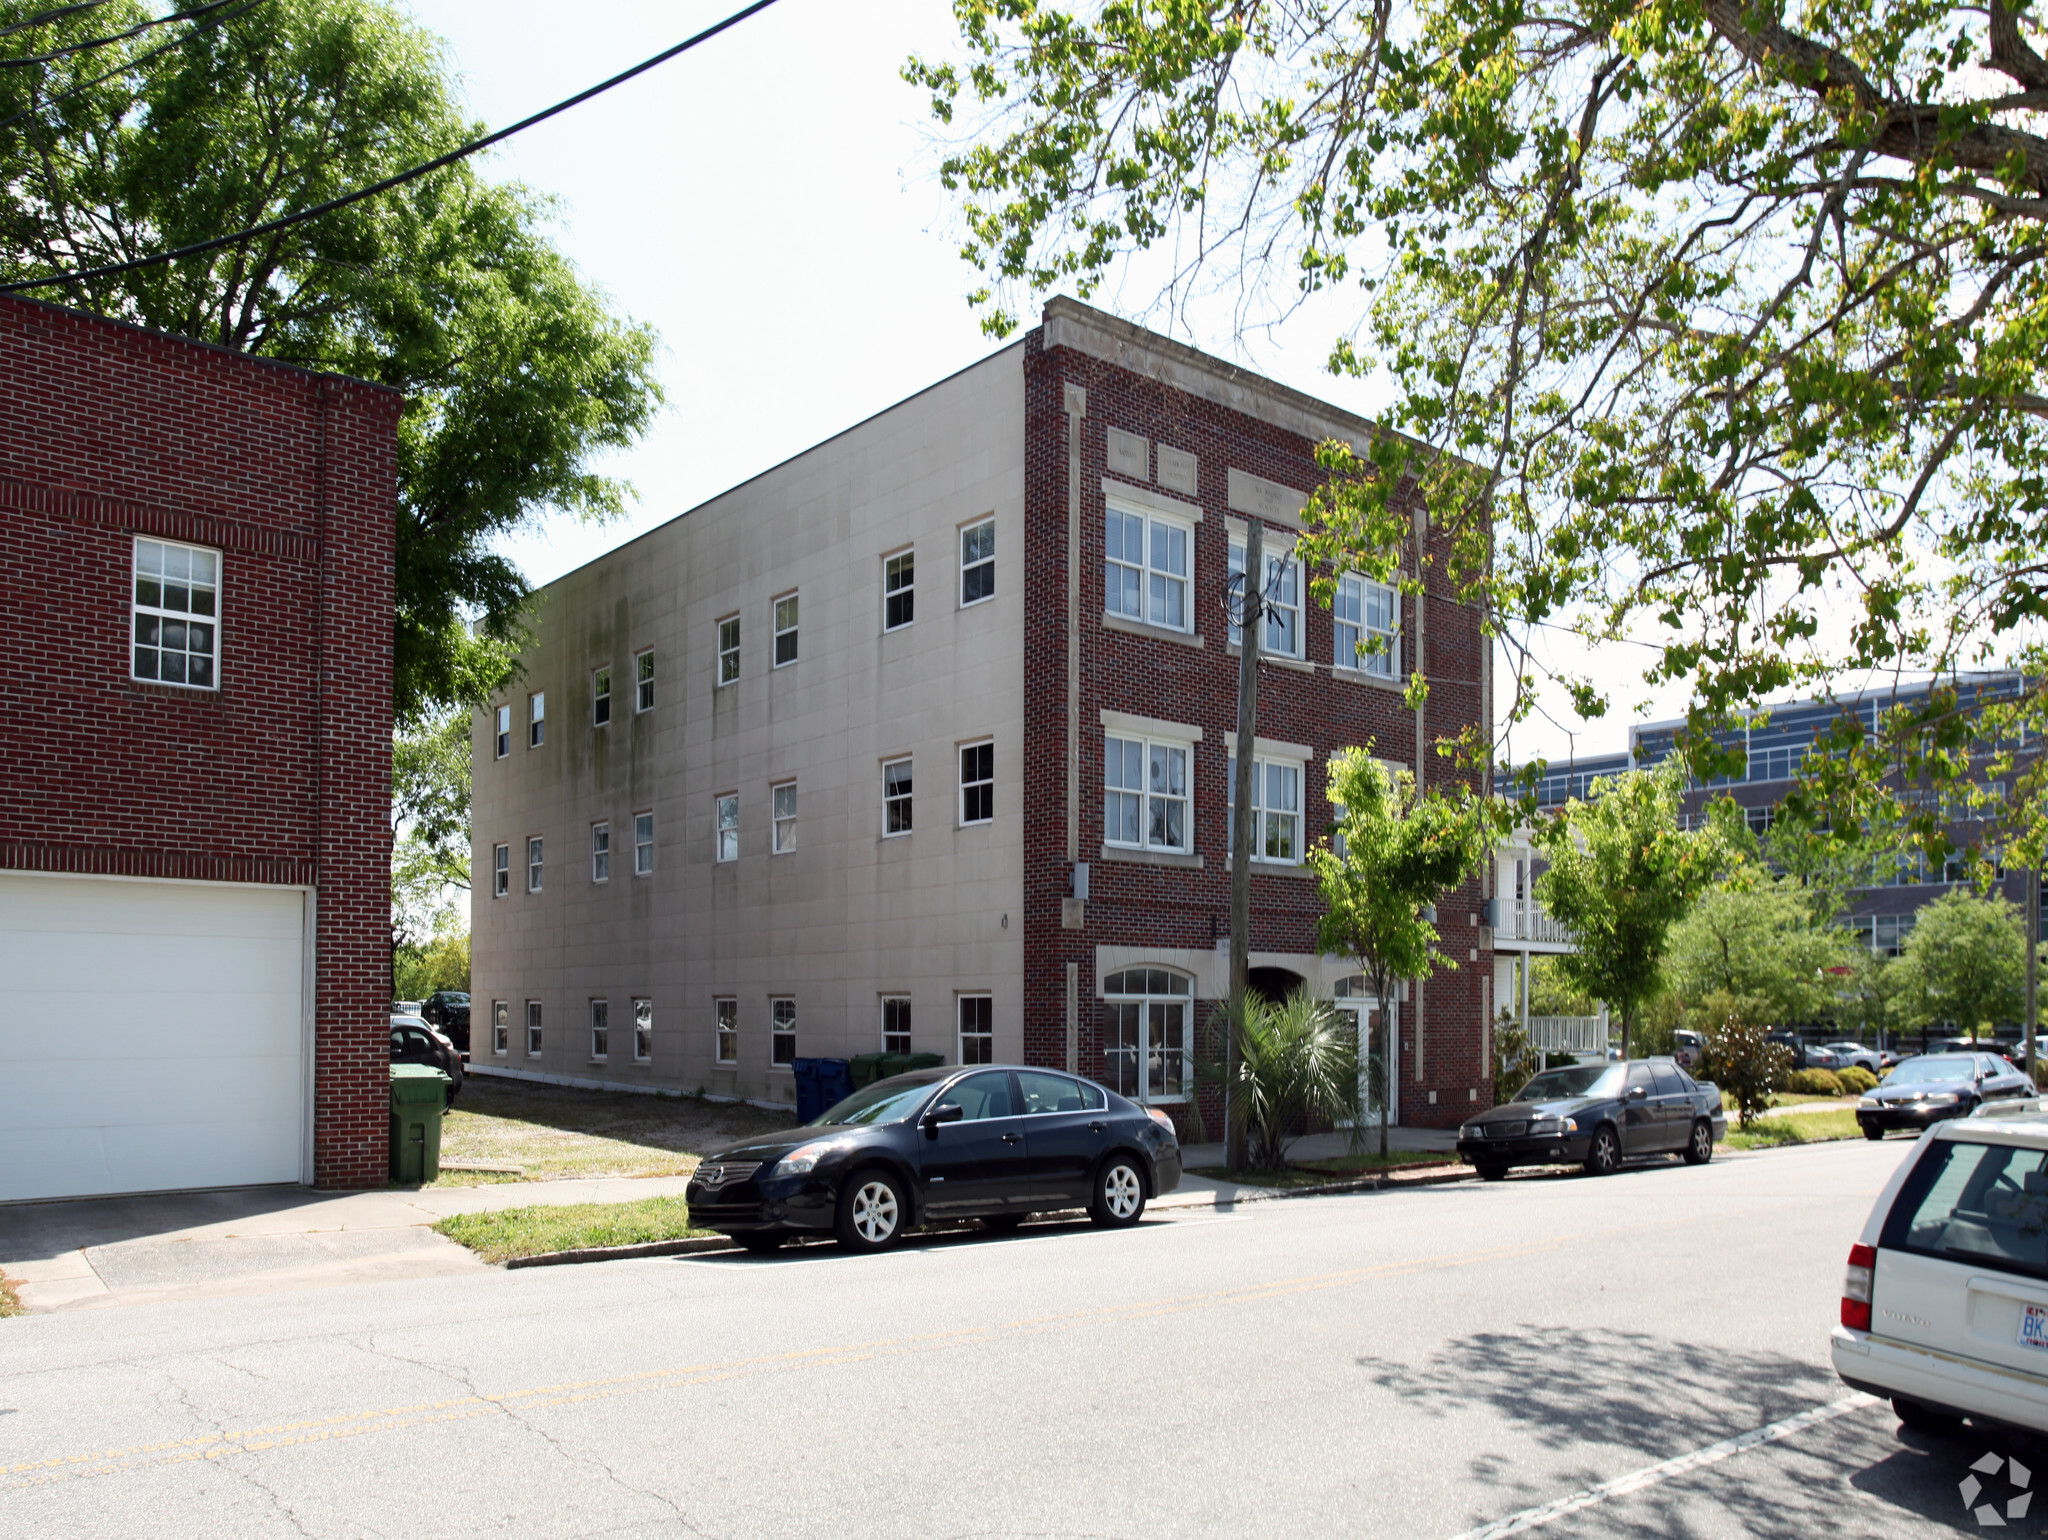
[1536, 760, 1722, 1059]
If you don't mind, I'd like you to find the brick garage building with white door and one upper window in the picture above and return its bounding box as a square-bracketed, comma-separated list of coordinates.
[0, 297, 401, 1198]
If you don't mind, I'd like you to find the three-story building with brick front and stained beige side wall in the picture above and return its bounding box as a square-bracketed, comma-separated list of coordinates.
[471, 299, 1493, 1124]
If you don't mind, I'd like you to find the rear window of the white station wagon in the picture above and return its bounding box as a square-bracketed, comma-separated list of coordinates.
[1878, 1139, 2048, 1278]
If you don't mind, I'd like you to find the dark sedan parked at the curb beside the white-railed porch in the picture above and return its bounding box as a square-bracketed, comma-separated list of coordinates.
[1458, 1059, 1729, 1182]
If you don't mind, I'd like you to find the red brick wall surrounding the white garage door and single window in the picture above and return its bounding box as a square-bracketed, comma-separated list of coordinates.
[0, 297, 401, 1188]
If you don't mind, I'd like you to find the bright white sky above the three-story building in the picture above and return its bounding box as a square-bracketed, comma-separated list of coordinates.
[412, 0, 1683, 760]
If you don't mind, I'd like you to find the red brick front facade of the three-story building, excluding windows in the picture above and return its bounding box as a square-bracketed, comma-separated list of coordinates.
[1024, 315, 1493, 1132]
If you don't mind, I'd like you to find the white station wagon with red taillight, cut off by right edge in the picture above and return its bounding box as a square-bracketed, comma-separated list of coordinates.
[1833, 1102, 2048, 1431]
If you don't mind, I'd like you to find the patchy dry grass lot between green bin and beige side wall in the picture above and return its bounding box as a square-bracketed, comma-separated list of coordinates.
[434, 1075, 797, 1188]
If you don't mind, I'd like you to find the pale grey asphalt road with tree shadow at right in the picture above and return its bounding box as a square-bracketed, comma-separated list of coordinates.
[0, 1143, 2023, 1540]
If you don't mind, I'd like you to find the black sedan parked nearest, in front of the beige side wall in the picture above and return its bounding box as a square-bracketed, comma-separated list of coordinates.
[688, 1065, 1180, 1251]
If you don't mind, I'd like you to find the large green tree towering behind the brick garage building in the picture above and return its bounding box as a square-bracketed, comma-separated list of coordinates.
[0, 0, 662, 717]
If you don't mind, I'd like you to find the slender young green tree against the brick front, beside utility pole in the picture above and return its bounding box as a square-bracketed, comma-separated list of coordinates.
[1309, 750, 1497, 1155]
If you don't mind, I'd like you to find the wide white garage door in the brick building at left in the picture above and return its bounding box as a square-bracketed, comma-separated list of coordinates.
[0, 872, 305, 1200]
